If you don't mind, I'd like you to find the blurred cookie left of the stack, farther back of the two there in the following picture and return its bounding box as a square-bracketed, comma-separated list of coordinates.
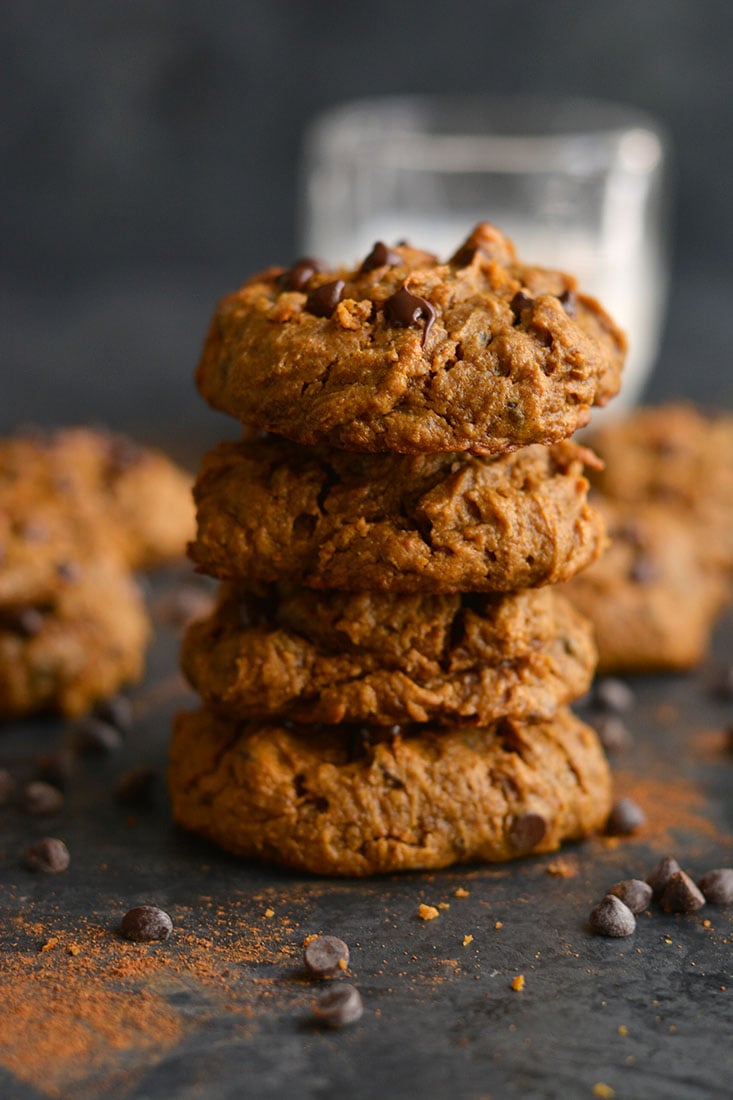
[0, 428, 194, 605]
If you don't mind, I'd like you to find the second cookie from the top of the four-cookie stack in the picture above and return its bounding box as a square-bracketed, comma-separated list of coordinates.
[189, 437, 604, 593]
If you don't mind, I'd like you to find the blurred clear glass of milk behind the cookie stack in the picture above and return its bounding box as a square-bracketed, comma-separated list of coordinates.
[299, 96, 669, 422]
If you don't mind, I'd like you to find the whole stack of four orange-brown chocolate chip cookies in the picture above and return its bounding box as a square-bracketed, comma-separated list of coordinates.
[169, 224, 624, 875]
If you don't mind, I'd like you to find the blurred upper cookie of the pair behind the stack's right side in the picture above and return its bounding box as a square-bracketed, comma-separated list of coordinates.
[592, 403, 733, 573]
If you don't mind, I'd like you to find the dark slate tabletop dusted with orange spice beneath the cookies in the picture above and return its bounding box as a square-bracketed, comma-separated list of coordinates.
[0, 594, 733, 1100]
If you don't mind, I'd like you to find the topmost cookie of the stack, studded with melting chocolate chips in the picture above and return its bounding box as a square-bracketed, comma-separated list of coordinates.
[196, 224, 625, 454]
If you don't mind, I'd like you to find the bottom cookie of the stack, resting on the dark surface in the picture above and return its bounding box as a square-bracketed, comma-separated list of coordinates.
[168, 710, 610, 876]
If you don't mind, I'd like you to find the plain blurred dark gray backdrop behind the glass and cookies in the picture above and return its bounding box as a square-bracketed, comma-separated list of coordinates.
[0, 0, 733, 446]
